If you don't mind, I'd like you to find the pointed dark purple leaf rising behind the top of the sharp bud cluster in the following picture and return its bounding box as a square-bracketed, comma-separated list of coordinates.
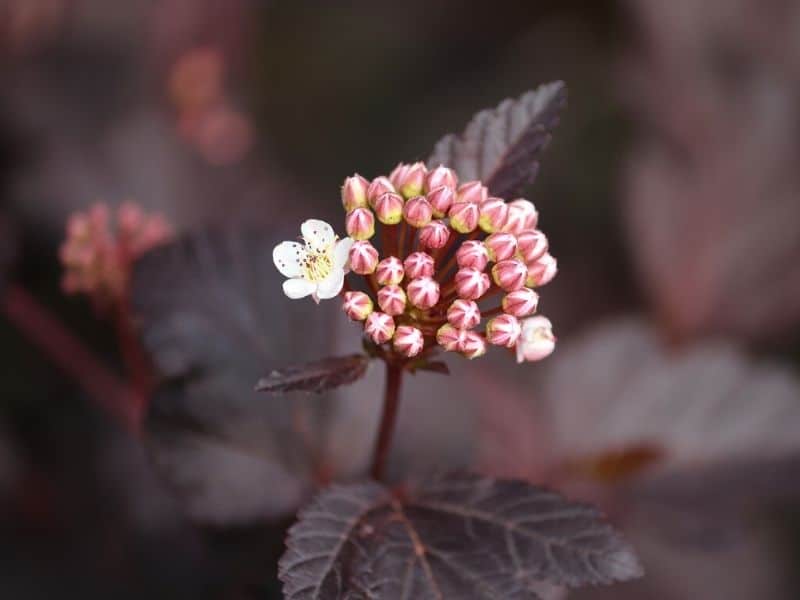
[428, 81, 567, 198]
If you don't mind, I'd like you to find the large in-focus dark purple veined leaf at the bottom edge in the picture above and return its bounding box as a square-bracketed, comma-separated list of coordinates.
[279, 475, 642, 600]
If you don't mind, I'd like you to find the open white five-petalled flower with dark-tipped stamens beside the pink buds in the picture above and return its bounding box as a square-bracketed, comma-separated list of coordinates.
[272, 219, 353, 302]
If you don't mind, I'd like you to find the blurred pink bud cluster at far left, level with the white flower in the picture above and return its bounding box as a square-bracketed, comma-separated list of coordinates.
[60, 202, 173, 306]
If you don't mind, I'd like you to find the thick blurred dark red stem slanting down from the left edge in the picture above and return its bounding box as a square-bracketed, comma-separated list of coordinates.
[2, 285, 143, 432]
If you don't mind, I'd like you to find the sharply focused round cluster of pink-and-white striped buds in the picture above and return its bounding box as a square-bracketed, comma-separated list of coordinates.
[332, 162, 557, 362]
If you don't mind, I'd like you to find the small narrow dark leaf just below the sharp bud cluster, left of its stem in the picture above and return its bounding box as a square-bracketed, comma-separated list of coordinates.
[256, 354, 369, 394]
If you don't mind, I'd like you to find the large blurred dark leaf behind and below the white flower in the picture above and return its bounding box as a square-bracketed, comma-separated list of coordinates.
[133, 231, 339, 524]
